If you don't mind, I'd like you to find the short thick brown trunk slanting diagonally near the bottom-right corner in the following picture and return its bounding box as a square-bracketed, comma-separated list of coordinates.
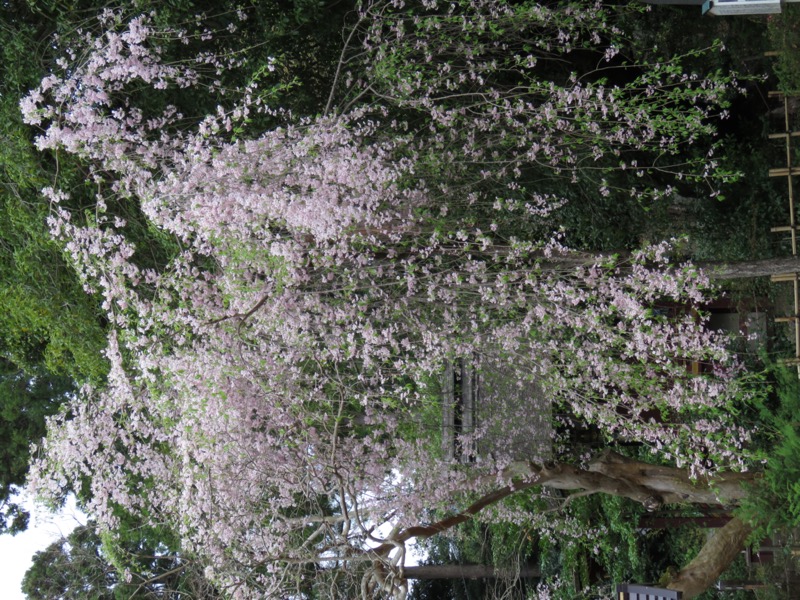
[667, 518, 753, 600]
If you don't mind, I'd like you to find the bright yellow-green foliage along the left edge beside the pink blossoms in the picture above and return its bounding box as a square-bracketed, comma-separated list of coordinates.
[0, 4, 112, 382]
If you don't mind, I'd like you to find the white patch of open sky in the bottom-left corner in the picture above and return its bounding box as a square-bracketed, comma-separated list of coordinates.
[0, 494, 86, 600]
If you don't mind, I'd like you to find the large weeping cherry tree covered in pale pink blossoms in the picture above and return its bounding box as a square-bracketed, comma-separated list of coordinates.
[22, 0, 764, 598]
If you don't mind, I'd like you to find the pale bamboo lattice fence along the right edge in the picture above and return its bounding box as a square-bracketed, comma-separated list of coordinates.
[769, 92, 800, 377]
